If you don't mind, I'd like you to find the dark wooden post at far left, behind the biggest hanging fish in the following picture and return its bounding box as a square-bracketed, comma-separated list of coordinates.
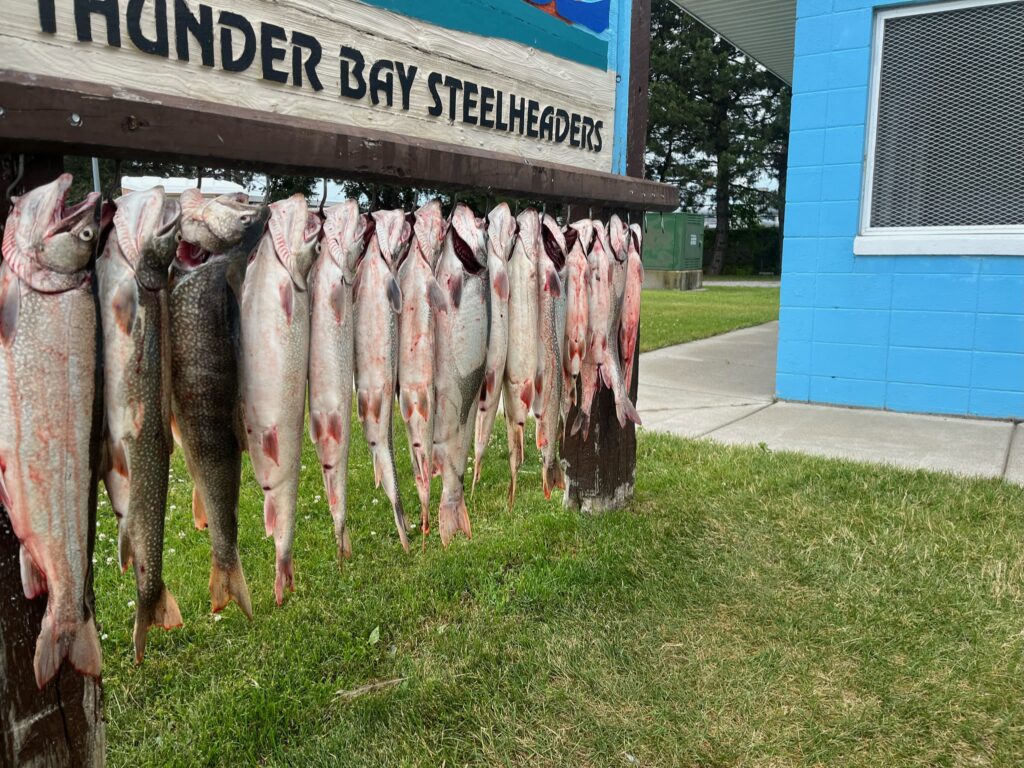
[0, 156, 104, 768]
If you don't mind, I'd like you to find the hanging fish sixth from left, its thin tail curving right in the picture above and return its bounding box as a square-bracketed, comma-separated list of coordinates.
[352, 211, 413, 552]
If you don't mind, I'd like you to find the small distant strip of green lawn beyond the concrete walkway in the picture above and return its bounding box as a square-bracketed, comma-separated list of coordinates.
[640, 287, 779, 352]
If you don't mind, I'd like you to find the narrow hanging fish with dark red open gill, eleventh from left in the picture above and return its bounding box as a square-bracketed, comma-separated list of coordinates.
[534, 214, 566, 499]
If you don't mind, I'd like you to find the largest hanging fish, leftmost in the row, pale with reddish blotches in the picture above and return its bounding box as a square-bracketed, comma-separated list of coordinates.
[0, 173, 101, 688]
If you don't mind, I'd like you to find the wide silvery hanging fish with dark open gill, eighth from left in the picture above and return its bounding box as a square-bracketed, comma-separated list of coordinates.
[434, 204, 490, 547]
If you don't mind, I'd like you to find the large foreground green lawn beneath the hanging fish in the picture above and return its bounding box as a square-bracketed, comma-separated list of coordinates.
[96, 417, 1024, 768]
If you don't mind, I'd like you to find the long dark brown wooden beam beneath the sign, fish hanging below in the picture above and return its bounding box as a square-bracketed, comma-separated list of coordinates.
[0, 70, 678, 211]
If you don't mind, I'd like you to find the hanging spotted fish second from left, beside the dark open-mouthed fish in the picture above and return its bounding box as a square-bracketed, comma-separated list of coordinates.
[96, 186, 181, 664]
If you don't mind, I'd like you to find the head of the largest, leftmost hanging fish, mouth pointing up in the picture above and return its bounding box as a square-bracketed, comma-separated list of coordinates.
[3, 173, 100, 274]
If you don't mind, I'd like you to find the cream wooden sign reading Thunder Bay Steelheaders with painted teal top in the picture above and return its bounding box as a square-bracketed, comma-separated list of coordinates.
[0, 0, 629, 173]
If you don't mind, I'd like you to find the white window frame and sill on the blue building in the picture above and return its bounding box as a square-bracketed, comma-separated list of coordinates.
[853, 0, 1024, 256]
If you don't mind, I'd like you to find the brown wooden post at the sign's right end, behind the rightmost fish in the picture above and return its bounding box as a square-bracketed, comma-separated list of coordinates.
[561, 0, 650, 513]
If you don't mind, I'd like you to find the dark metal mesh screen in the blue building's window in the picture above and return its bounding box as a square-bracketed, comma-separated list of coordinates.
[870, 2, 1024, 227]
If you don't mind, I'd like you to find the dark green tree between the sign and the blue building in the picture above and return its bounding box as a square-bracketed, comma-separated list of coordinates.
[647, 0, 790, 274]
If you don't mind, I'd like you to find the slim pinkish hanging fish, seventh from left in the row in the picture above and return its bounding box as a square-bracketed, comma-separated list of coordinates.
[398, 200, 447, 546]
